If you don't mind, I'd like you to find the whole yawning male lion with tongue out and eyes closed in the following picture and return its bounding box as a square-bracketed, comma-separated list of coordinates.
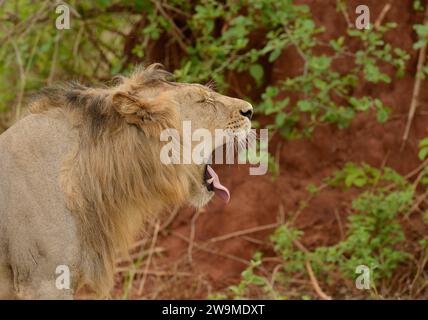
[0, 64, 253, 299]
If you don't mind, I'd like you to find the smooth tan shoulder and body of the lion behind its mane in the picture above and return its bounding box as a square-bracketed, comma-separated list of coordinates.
[0, 111, 78, 292]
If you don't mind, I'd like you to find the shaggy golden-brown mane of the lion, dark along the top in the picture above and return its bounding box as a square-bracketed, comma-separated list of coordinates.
[30, 64, 198, 295]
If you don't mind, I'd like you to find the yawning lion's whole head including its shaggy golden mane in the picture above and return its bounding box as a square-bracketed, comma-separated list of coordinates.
[30, 64, 253, 293]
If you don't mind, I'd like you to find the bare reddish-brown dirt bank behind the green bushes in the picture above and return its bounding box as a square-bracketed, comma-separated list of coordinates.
[94, 0, 428, 299]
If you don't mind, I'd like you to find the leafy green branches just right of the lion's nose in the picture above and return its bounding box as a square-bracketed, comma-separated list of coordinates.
[258, 23, 409, 138]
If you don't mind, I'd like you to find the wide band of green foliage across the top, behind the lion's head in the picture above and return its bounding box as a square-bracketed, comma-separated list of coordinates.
[0, 0, 408, 138]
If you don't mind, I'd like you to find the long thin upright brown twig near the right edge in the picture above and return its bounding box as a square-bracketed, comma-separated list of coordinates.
[400, 5, 428, 151]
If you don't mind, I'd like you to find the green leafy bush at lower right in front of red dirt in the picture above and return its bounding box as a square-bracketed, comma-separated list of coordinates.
[217, 163, 425, 299]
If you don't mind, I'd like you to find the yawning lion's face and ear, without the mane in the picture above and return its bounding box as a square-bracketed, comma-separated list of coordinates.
[108, 64, 253, 207]
